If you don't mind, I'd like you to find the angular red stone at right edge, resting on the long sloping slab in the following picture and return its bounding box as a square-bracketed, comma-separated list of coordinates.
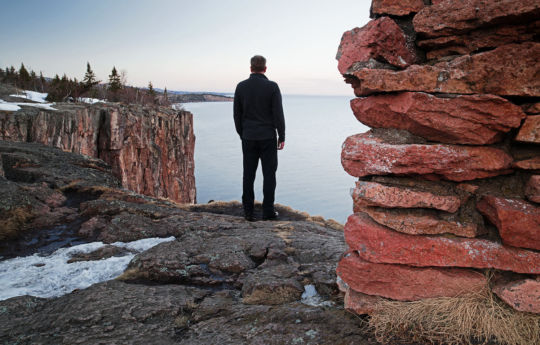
[476, 195, 540, 250]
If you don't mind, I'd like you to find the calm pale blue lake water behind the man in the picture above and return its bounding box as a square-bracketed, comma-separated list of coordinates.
[185, 95, 368, 222]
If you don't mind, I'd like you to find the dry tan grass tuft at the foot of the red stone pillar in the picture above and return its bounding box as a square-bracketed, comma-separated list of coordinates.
[369, 287, 540, 345]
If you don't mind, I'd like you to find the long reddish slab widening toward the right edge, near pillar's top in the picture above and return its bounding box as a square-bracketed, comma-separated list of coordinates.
[346, 42, 540, 97]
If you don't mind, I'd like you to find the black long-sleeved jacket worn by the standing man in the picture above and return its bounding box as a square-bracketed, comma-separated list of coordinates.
[234, 73, 285, 142]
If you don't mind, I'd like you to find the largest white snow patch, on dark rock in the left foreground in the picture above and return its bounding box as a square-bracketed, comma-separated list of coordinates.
[0, 237, 175, 300]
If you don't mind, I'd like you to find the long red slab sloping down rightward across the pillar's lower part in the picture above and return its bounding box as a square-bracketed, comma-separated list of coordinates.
[345, 213, 540, 274]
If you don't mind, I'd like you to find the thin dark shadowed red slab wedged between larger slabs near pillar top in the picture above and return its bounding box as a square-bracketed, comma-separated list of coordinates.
[416, 21, 540, 59]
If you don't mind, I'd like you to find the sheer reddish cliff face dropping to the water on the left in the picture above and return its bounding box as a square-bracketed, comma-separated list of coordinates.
[0, 104, 196, 203]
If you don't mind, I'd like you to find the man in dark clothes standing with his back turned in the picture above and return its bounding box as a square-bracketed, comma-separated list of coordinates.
[234, 55, 285, 222]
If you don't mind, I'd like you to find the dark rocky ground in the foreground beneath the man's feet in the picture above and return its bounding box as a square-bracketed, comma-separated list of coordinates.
[0, 141, 380, 344]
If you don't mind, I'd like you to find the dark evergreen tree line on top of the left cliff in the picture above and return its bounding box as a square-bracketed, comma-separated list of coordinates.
[0, 62, 170, 105]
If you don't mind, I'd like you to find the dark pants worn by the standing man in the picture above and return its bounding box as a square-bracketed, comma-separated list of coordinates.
[242, 139, 277, 215]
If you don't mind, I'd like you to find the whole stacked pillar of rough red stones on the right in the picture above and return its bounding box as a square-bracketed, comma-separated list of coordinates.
[337, 0, 540, 314]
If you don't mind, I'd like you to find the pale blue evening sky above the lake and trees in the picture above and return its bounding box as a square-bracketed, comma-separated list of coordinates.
[0, 0, 371, 95]
